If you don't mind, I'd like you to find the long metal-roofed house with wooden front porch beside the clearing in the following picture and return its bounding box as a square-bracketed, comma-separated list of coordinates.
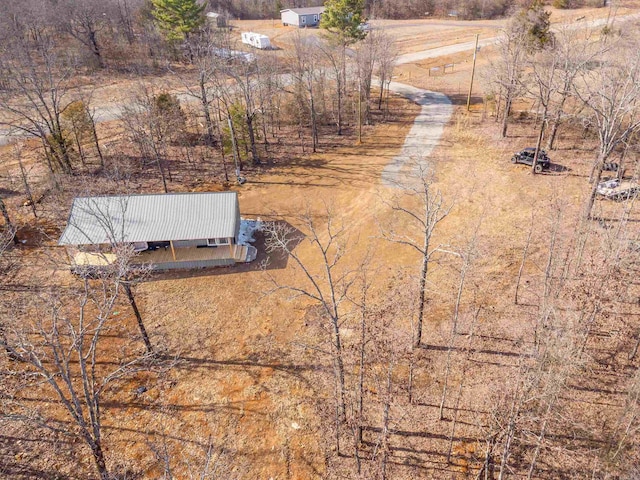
[58, 192, 256, 270]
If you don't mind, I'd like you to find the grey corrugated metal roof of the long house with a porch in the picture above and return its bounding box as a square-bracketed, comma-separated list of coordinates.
[58, 192, 239, 245]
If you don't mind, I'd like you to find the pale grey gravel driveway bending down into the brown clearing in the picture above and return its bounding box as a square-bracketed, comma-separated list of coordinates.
[382, 82, 453, 187]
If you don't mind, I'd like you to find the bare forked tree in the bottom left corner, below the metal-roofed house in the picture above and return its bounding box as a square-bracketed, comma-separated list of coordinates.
[3, 275, 156, 480]
